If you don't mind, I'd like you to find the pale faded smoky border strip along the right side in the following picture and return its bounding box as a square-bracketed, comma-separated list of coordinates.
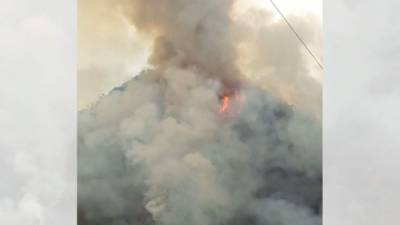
[323, 0, 400, 225]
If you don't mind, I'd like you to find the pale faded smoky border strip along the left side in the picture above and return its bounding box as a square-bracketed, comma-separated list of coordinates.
[0, 0, 76, 225]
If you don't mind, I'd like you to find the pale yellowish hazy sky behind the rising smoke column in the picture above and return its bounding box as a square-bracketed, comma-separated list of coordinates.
[78, 0, 322, 109]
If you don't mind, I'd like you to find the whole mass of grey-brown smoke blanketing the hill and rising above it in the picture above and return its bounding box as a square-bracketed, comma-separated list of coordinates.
[78, 0, 322, 225]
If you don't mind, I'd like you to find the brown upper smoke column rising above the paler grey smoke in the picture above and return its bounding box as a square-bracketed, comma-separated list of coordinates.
[122, 0, 241, 89]
